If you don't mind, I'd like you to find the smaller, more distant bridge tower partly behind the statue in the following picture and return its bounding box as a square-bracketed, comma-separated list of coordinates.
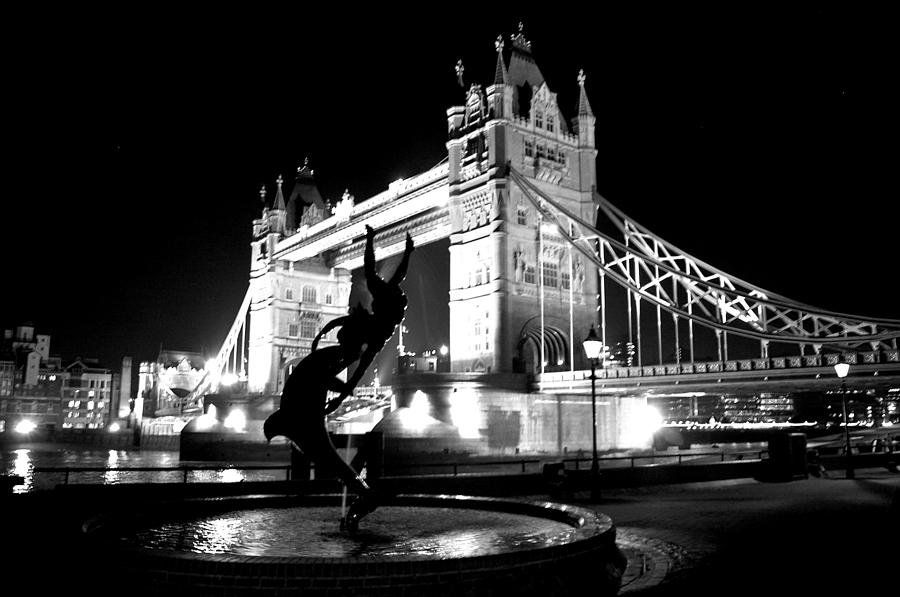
[247, 163, 350, 394]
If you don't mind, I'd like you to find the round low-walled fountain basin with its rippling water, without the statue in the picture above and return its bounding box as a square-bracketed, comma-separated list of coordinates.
[84, 495, 625, 595]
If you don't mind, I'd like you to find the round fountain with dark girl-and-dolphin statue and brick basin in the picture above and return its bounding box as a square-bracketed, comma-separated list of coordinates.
[83, 229, 625, 596]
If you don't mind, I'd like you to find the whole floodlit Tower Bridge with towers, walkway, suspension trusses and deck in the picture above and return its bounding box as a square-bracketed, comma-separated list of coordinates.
[181, 24, 900, 448]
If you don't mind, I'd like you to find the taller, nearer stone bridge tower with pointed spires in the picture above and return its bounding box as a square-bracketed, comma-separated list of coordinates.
[447, 25, 597, 373]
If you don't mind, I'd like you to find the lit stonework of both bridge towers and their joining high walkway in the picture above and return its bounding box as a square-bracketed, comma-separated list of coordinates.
[248, 32, 597, 393]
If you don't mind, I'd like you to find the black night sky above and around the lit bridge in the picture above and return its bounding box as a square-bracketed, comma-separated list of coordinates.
[0, 3, 900, 378]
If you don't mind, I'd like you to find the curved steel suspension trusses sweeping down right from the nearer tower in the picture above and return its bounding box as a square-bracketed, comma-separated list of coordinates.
[509, 167, 900, 354]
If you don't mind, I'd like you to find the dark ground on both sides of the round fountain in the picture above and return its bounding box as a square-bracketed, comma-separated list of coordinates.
[0, 468, 900, 597]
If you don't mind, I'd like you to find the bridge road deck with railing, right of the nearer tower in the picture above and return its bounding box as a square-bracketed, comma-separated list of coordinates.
[529, 349, 900, 395]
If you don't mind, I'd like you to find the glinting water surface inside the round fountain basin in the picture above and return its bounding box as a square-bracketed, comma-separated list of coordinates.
[123, 506, 575, 559]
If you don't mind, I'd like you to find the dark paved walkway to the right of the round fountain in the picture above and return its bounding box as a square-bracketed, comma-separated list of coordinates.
[564, 469, 900, 597]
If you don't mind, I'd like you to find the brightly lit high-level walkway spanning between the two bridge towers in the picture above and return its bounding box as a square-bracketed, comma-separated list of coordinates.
[274, 164, 450, 270]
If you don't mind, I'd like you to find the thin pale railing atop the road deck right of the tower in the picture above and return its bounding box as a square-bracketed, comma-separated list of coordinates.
[538, 349, 900, 382]
